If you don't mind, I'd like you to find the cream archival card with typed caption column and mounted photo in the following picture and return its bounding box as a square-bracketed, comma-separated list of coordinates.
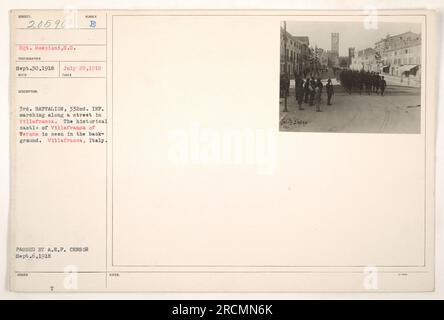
[9, 8, 436, 292]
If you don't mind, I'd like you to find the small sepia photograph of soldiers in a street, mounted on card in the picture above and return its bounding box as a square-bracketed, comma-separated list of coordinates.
[279, 21, 422, 134]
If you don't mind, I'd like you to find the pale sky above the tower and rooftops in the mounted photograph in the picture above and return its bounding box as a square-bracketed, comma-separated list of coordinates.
[287, 21, 421, 56]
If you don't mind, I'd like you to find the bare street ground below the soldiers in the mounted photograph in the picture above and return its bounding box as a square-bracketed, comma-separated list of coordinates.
[279, 82, 421, 133]
